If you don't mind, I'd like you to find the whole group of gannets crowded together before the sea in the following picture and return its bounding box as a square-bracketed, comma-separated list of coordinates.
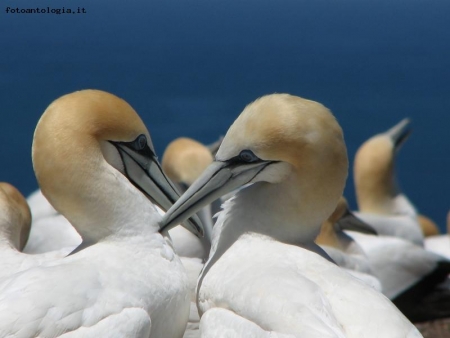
[0, 90, 450, 338]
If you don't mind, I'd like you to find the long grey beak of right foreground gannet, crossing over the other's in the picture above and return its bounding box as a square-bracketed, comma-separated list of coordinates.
[160, 161, 273, 229]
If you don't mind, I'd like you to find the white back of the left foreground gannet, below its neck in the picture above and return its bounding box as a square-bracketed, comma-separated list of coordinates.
[0, 236, 189, 337]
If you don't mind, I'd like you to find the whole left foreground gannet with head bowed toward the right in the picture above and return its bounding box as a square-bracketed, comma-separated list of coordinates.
[0, 90, 202, 338]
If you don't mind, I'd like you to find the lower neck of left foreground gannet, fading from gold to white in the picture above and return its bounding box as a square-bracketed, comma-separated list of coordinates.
[45, 164, 159, 243]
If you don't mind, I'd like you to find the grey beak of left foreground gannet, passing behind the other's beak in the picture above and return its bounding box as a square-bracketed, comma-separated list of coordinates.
[111, 141, 204, 237]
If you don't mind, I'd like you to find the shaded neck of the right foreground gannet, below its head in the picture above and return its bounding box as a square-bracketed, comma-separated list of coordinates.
[207, 170, 342, 274]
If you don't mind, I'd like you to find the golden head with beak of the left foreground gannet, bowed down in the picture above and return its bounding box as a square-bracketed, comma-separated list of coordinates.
[32, 90, 203, 241]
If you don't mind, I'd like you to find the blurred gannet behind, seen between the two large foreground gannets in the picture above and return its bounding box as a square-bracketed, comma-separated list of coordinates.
[161, 137, 213, 338]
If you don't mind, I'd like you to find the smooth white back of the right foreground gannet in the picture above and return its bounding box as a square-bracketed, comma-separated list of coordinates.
[199, 234, 420, 338]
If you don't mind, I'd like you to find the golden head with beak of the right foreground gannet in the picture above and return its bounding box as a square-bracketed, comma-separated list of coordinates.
[163, 94, 348, 238]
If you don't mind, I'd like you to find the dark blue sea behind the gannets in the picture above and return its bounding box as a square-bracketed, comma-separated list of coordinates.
[0, 0, 450, 229]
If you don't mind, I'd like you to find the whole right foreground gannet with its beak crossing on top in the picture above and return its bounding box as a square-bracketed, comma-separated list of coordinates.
[161, 94, 421, 338]
